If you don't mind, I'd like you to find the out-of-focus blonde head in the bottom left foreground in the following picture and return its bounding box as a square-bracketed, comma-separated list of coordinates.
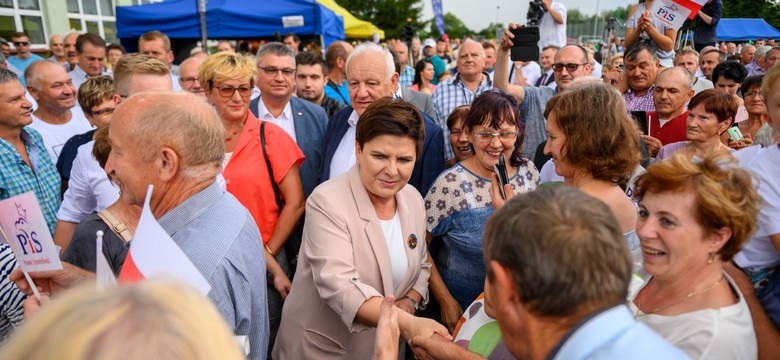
[2, 281, 243, 360]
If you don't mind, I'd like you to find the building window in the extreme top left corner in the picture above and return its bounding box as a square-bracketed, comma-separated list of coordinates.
[0, 0, 47, 46]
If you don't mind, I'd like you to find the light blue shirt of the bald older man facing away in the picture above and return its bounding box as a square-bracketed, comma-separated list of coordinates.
[159, 181, 269, 360]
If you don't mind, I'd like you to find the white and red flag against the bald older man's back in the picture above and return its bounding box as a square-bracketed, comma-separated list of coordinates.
[119, 185, 211, 295]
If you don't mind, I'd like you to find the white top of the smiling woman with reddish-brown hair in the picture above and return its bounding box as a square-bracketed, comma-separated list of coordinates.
[628, 273, 758, 360]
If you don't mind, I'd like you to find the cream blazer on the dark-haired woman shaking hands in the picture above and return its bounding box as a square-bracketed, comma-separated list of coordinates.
[272, 166, 431, 360]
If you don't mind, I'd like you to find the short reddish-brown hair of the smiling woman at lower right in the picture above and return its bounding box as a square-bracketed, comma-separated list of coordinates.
[634, 152, 761, 261]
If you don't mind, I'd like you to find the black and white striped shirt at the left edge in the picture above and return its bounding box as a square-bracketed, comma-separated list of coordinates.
[0, 243, 27, 344]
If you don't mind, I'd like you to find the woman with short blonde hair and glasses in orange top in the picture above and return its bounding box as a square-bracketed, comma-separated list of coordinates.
[198, 52, 304, 352]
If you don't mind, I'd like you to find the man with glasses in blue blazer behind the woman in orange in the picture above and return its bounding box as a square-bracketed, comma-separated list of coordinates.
[249, 43, 328, 197]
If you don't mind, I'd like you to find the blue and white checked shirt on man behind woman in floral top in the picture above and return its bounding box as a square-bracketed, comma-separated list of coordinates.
[433, 73, 493, 159]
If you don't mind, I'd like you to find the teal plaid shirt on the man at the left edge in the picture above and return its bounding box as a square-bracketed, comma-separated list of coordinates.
[0, 126, 61, 234]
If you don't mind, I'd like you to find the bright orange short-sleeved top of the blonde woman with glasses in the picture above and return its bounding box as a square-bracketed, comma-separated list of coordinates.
[222, 112, 304, 244]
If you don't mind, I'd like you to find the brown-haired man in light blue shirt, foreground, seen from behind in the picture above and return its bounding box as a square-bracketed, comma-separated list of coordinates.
[412, 186, 688, 360]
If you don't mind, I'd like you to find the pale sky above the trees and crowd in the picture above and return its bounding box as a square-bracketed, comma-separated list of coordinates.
[422, 0, 637, 31]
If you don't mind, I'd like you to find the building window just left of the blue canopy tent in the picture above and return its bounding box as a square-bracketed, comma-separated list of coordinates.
[68, 0, 118, 43]
